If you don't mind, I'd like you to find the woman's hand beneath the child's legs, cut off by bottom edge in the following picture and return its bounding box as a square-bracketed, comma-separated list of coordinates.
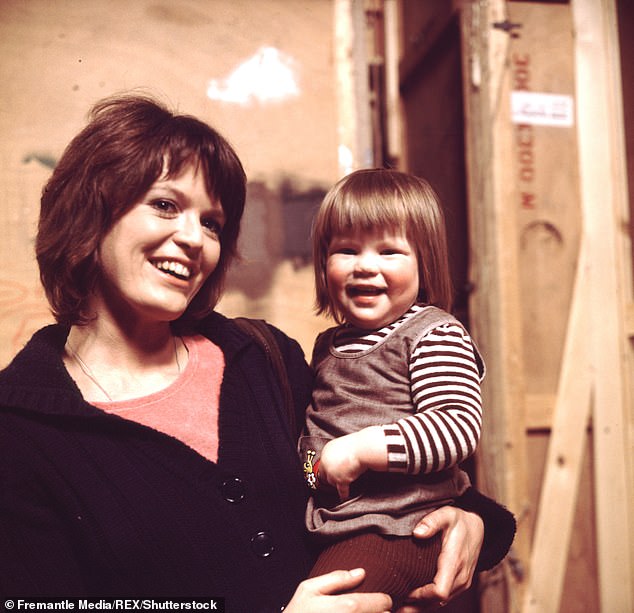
[284, 568, 392, 613]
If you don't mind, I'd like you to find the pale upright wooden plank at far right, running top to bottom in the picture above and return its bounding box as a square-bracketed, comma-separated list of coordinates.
[572, 0, 634, 613]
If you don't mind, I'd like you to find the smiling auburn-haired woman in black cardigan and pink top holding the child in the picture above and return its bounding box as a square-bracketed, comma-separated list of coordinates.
[0, 96, 513, 613]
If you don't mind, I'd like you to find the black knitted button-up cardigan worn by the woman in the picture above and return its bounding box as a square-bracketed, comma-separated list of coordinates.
[0, 313, 514, 613]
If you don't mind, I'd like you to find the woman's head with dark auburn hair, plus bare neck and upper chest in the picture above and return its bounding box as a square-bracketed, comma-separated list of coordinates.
[36, 97, 245, 401]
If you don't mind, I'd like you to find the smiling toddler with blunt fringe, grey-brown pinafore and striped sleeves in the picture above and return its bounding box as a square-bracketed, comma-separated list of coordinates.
[300, 169, 484, 608]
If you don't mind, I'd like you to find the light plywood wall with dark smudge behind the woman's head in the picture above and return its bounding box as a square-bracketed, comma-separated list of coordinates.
[0, 0, 339, 365]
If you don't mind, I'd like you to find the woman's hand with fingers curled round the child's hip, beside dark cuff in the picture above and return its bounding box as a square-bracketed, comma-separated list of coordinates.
[398, 506, 484, 613]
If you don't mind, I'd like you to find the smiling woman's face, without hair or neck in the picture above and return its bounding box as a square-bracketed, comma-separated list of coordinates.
[95, 165, 225, 321]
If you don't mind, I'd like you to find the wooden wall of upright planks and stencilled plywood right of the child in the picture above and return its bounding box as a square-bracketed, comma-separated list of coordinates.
[463, 0, 633, 612]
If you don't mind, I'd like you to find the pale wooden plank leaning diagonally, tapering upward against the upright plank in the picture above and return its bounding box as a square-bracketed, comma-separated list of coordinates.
[522, 244, 592, 613]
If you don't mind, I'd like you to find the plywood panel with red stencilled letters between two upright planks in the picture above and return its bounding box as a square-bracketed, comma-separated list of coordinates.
[508, 2, 581, 421]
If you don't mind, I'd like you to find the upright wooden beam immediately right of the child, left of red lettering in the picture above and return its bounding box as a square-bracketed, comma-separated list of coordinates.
[461, 0, 530, 613]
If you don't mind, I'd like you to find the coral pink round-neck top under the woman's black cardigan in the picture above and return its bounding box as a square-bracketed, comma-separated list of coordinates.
[93, 335, 225, 462]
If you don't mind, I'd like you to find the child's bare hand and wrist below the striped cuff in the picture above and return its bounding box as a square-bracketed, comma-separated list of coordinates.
[319, 426, 387, 500]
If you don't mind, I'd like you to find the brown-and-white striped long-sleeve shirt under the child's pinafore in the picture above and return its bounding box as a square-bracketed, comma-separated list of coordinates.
[335, 305, 482, 474]
